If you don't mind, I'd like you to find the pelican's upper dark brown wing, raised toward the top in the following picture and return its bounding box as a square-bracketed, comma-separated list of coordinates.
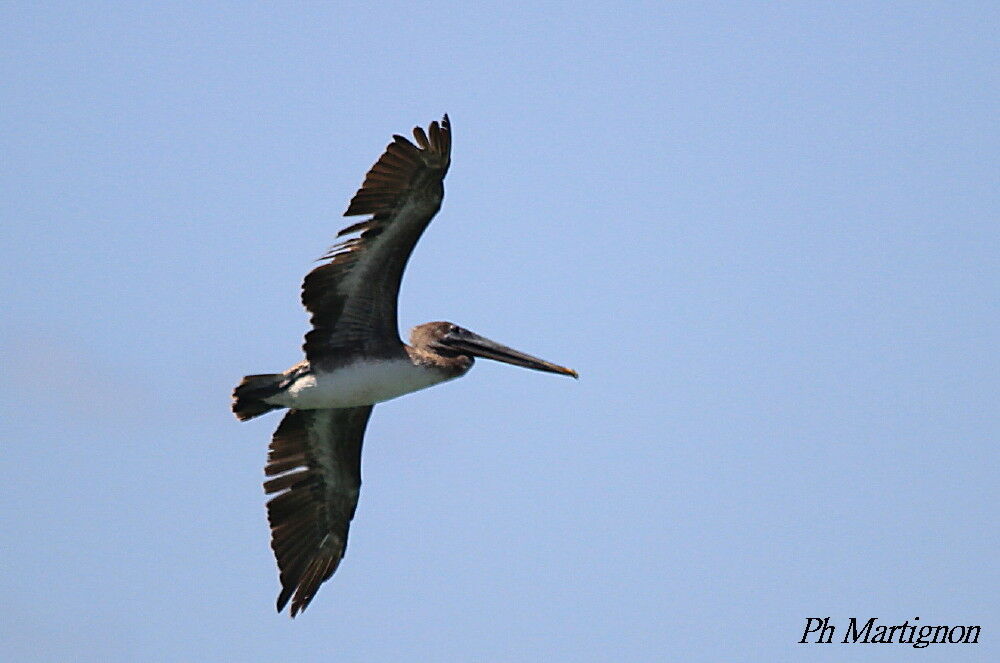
[302, 115, 451, 362]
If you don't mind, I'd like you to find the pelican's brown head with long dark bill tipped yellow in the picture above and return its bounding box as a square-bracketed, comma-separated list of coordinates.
[410, 322, 579, 378]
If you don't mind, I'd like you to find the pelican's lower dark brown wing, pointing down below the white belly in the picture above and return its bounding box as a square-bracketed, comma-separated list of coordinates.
[264, 405, 372, 617]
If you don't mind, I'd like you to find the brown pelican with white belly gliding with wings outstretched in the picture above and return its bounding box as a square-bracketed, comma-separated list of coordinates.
[233, 115, 577, 617]
